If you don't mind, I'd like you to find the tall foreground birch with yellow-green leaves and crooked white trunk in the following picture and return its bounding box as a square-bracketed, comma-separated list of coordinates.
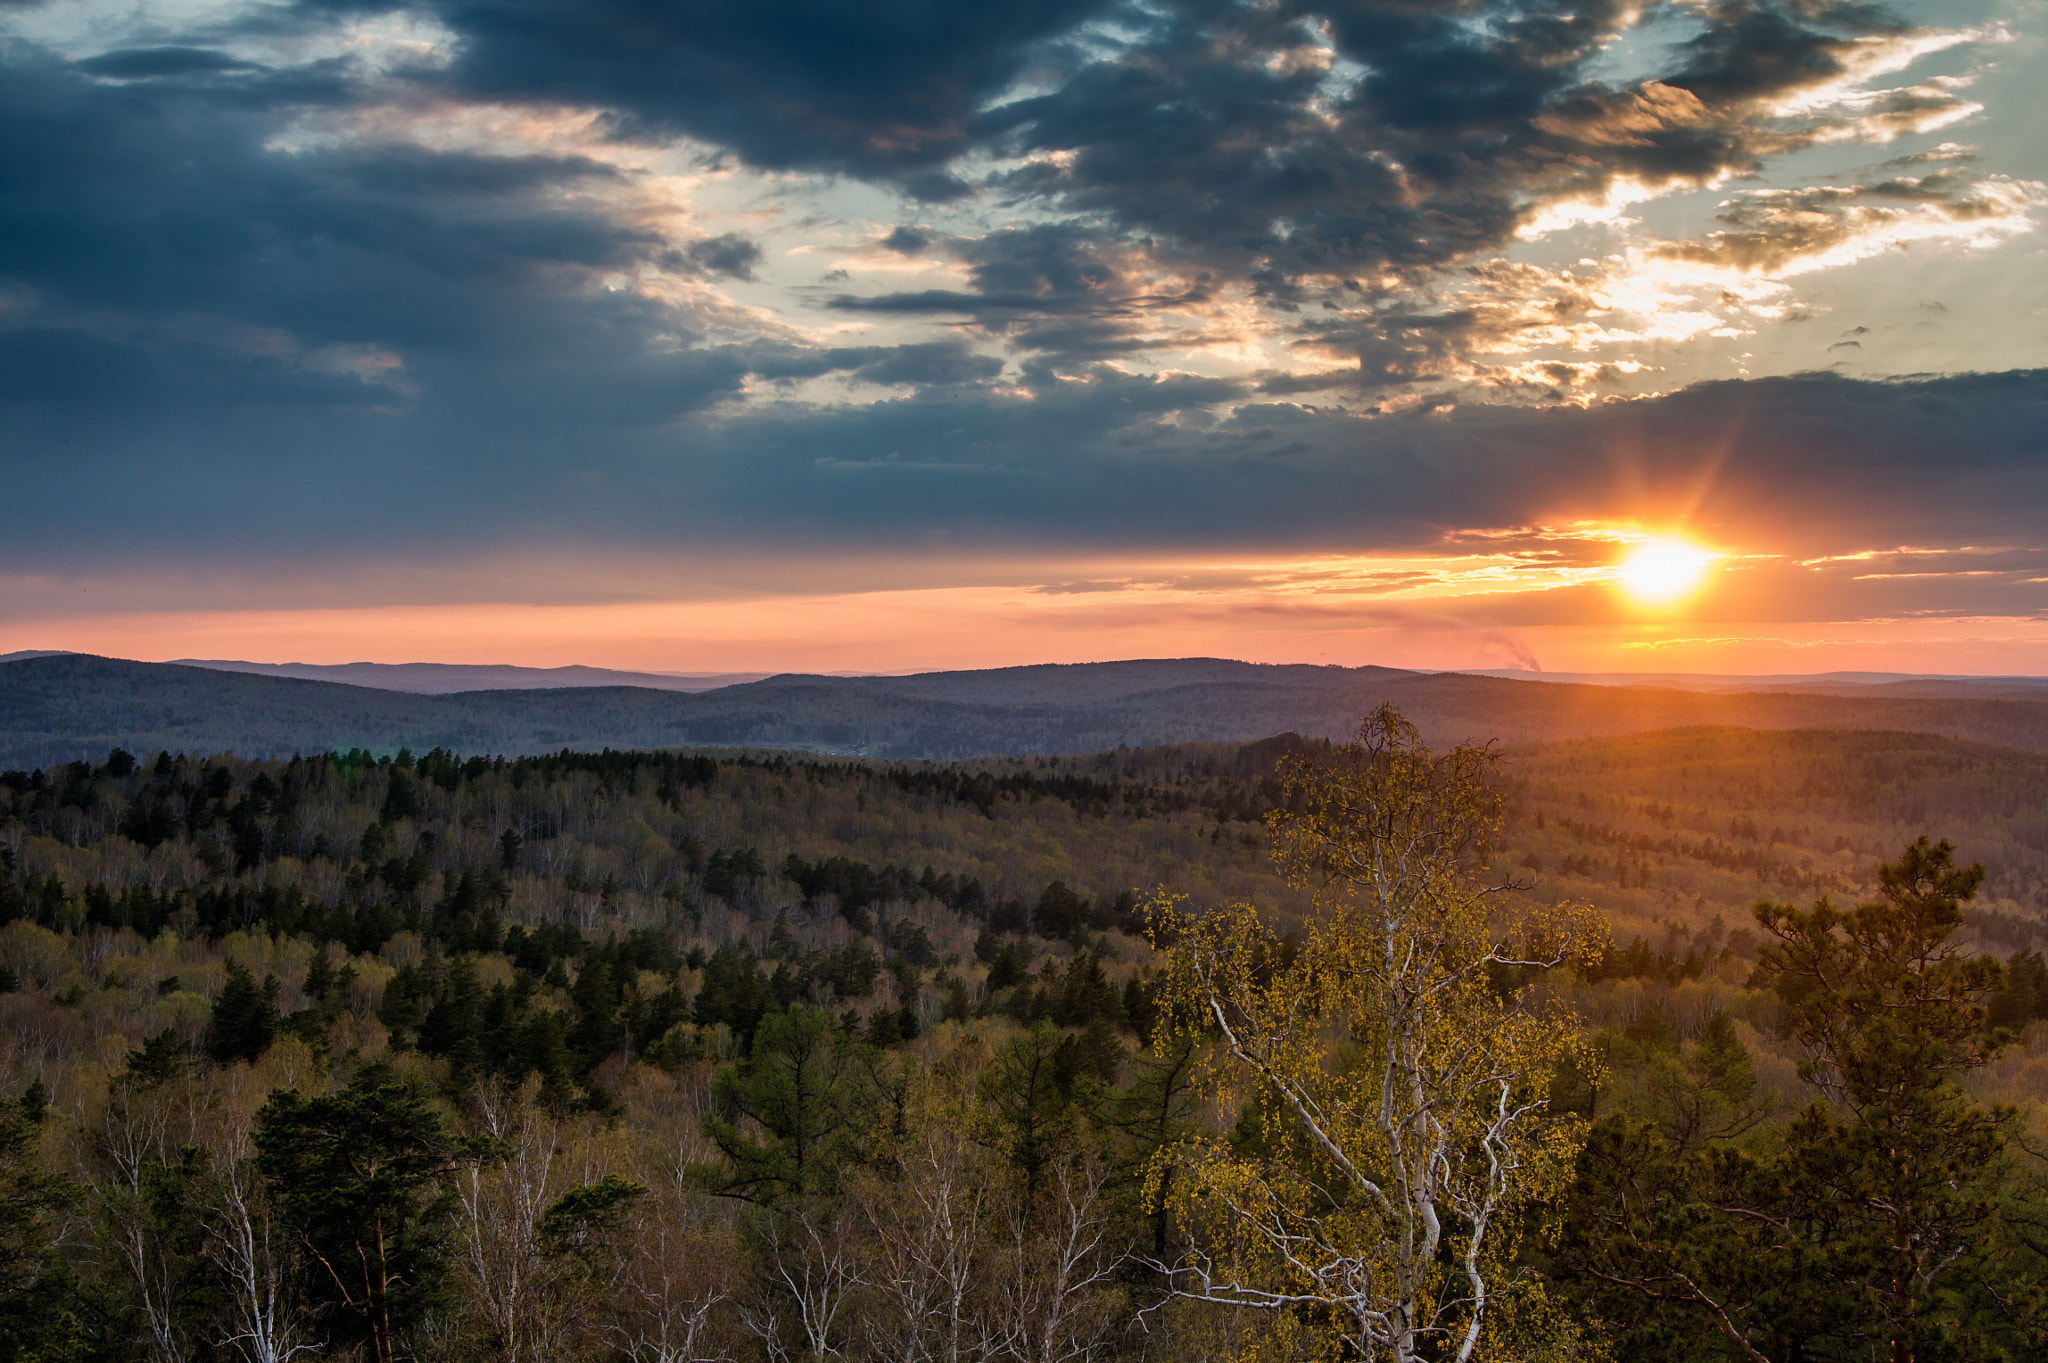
[1149, 704, 1597, 1363]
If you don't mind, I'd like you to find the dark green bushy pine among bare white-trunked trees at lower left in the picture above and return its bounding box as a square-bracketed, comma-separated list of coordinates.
[256, 1066, 492, 1363]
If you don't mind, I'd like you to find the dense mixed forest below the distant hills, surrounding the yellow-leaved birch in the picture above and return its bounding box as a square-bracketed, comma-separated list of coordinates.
[0, 727, 2048, 1363]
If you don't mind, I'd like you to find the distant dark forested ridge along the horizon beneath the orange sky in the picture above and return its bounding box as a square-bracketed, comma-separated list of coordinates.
[12, 655, 2048, 770]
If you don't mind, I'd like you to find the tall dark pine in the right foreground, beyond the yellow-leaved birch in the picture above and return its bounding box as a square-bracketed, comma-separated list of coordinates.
[1561, 837, 2030, 1363]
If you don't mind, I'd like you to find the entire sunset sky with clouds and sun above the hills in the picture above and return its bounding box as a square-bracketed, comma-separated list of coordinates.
[0, 0, 2048, 675]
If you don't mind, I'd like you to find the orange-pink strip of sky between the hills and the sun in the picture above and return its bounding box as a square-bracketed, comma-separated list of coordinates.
[0, 587, 2048, 675]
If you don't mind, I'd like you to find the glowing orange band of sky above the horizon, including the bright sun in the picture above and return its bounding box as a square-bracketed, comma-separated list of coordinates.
[12, 536, 2048, 675]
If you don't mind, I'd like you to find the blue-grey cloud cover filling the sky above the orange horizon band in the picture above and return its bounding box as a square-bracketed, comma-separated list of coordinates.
[0, 0, 2048, 628]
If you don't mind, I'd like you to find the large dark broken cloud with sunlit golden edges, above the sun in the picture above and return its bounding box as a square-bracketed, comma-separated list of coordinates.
[761, 0, 2017, 382]
